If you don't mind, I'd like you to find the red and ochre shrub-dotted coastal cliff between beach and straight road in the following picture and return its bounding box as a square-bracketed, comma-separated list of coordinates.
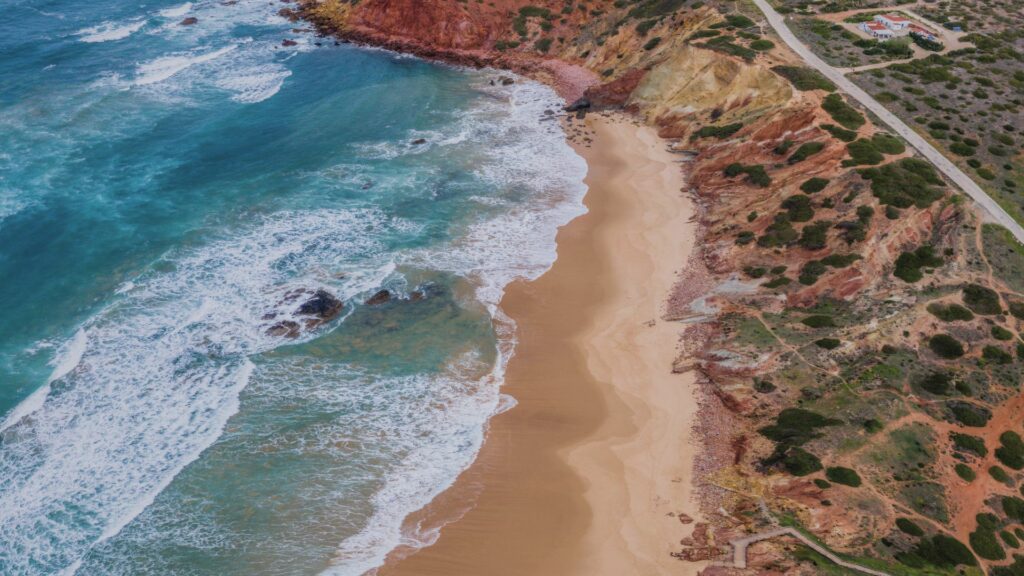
[292, 0, 1024, 574]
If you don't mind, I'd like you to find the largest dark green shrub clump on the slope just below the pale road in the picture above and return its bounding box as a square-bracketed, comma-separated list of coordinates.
[860, 158, 944, 208]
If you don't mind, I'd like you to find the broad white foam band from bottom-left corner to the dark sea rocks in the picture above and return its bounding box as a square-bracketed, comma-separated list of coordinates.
[0, 206, 407, 574]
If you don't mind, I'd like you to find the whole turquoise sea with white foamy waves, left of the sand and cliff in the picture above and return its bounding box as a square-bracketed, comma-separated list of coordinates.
[0, 0, 585, 576]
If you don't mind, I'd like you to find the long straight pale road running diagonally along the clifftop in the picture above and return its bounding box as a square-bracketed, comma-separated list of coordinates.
[754, 0, 1024, 243]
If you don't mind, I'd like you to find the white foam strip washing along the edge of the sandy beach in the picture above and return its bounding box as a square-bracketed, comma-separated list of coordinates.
[324, 72, 587, 576]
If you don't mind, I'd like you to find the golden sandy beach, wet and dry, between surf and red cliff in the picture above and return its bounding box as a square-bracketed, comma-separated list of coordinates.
[379, 115, 700, 576]
